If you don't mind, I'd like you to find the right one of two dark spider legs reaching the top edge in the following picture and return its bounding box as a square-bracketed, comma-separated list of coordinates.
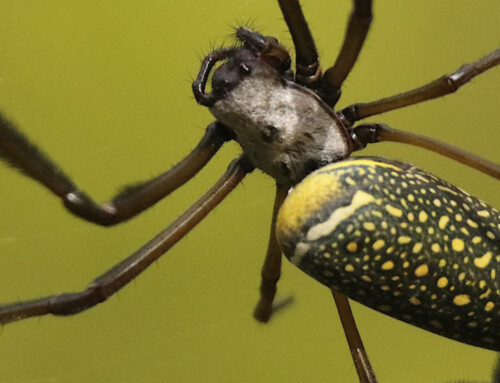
[318, 0, 373, 107]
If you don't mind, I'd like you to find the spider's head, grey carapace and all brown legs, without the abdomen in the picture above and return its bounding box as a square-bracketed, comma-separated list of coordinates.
[0, 0, 500, 381]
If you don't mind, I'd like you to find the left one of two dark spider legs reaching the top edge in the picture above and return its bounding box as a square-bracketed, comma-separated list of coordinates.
[278, 0, 321, 89]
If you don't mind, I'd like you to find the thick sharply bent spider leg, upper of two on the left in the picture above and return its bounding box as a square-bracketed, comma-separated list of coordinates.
[0, 114, 231, 226]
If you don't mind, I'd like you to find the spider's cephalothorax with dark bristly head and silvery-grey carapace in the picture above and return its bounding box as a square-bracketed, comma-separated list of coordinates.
[194, 28, 354, 185]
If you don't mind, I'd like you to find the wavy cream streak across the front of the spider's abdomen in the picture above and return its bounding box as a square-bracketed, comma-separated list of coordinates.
[306, 191, 375, 241]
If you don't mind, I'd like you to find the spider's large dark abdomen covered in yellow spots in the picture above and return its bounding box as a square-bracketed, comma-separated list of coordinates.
[277, 157, 500, 350]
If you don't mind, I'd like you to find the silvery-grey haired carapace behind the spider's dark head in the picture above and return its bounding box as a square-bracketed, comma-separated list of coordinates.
[210, 71, 350, 183]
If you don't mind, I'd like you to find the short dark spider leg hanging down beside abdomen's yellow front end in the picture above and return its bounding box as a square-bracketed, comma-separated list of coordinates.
[253, 184, 288, 322]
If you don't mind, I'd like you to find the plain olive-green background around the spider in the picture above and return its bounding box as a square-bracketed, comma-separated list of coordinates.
[0, 0, 500, 383]
